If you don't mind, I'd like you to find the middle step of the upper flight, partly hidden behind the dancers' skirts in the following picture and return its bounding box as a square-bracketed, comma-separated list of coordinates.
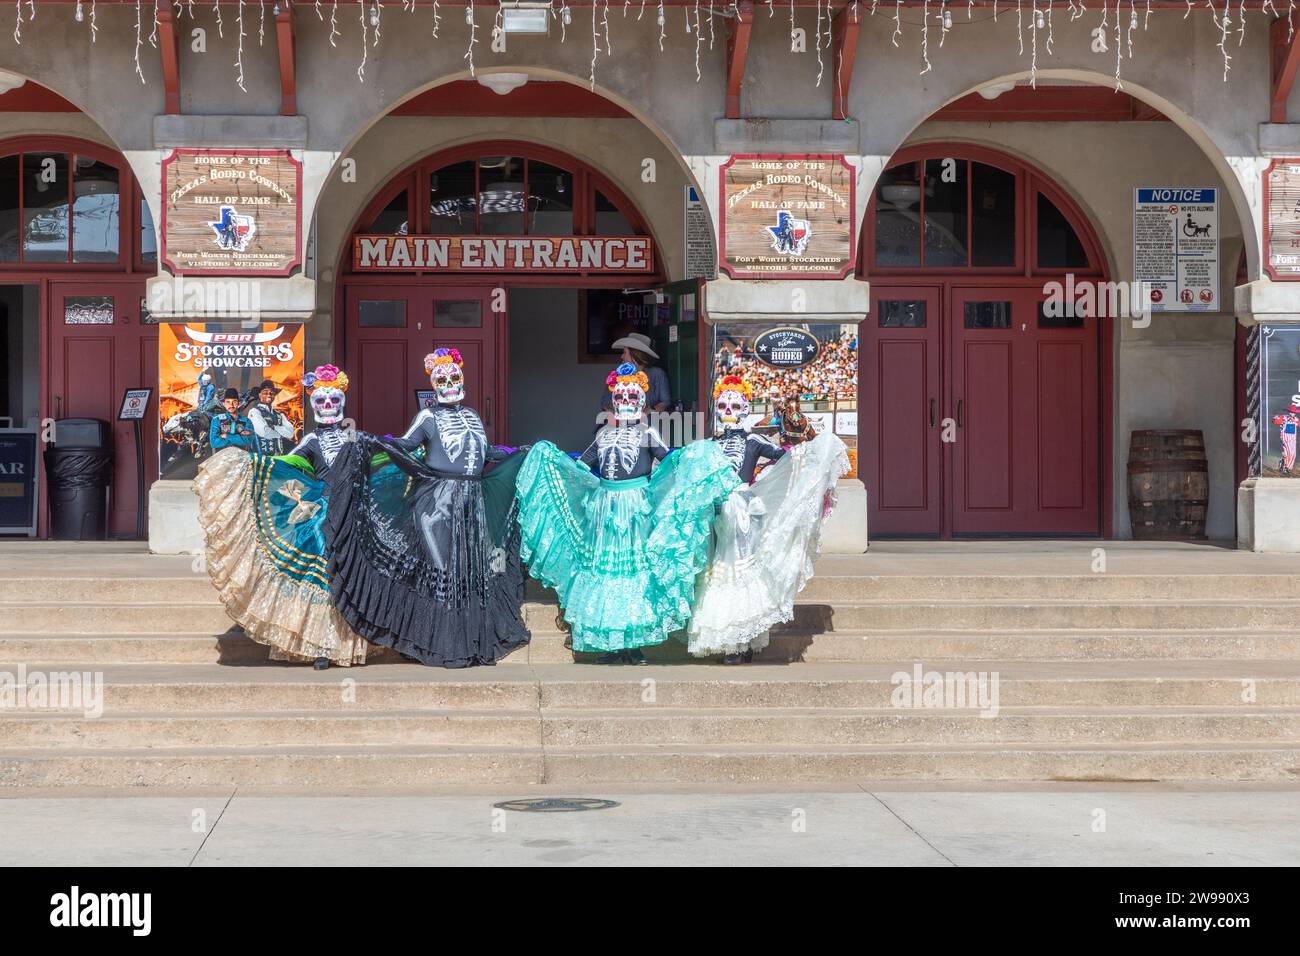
[0, 600, 1300, 636]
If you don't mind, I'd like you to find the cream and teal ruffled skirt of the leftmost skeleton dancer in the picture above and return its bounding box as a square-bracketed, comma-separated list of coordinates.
[194, 447, 367, 666]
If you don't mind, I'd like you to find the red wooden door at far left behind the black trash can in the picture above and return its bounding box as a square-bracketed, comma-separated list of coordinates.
[42, 277, 159, 536]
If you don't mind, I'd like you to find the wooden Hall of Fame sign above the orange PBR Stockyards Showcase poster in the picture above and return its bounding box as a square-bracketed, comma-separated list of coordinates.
[160, 150, 303, 276]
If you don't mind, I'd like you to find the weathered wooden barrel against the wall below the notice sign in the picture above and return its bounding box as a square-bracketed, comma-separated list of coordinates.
[1128, 429, 1210, 541]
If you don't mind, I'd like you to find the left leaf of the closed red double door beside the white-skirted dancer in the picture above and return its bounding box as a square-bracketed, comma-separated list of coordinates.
[859, 287, 944, 536]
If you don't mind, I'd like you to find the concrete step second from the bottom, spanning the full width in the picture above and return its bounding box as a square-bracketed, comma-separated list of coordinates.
[0, 706, 1300, 758]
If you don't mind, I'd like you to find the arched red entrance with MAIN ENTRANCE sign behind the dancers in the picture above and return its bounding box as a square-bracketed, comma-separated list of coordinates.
[335, 140, 696, 446]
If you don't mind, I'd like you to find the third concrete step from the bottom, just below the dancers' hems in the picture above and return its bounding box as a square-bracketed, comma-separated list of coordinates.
[7, 661, 1300, 715]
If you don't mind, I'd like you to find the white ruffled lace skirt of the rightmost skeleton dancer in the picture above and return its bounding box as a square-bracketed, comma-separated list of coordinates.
[686, 432, 849, 657]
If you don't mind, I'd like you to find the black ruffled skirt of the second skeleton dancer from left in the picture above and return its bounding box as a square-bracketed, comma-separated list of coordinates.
[329, 434, 529, 667]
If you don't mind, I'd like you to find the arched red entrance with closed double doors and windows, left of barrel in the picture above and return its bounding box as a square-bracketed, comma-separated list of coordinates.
[859, 143, 1110, 537]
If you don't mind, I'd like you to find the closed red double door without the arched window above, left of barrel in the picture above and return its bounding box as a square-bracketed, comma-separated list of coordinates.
[859, 285, 1101, 537]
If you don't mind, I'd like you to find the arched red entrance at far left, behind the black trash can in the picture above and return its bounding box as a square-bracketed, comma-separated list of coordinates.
[0, 137, 157, 537]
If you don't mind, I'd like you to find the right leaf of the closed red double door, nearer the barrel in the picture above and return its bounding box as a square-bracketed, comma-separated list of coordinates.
[944, 287, 1101, 535]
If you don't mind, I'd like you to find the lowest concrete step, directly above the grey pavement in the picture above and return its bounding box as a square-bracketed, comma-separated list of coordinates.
[0, 741, 1300, 796]
